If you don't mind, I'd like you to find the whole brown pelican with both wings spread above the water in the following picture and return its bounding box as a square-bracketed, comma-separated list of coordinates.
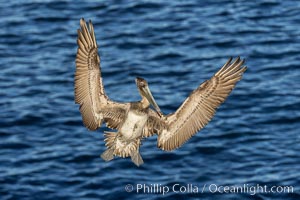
[75, 19, 246, 166]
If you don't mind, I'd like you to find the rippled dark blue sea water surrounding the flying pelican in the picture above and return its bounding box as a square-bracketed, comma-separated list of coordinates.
[0, 0, 300, 200]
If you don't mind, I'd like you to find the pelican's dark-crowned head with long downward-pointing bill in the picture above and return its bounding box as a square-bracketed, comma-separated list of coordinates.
[135, 77, 161, 115]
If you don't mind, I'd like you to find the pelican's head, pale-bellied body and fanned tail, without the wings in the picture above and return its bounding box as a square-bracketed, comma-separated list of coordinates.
[101, 78, 161, 166]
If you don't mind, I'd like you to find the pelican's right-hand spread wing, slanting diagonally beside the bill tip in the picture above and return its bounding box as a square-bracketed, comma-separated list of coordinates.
[145, 58, 246, 151]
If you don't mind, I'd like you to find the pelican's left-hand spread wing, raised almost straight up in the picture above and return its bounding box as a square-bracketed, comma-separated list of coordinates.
[75, 19, 129, 130]
